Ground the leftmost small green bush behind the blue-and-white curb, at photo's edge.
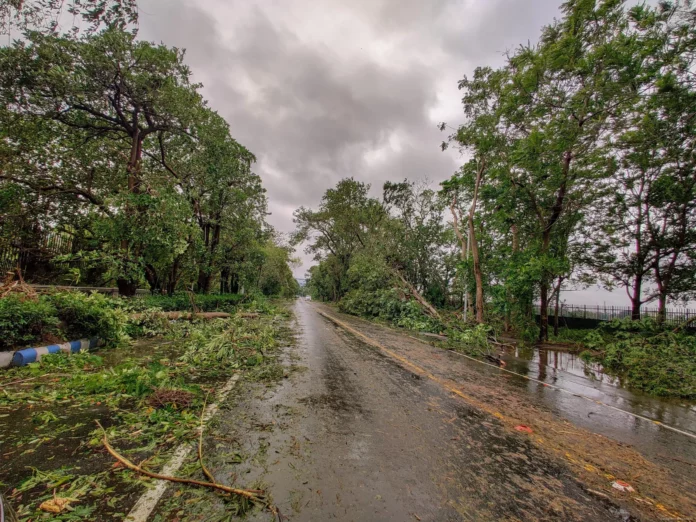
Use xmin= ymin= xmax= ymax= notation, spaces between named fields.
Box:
xmin=0 ymin=294 xmax=58 ymax=350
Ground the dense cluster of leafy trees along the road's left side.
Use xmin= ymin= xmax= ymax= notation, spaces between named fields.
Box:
xmin=0 ymin=23 xmax=297 ymax=295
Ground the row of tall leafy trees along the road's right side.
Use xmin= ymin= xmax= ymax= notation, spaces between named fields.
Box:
xmin=296 ymin=0 xmax=696 ymax=339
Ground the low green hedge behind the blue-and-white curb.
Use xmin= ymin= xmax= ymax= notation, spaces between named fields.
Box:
xmin=0 ymin=292 xmax=126 ymax=350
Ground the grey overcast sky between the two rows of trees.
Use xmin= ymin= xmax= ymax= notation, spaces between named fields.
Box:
xmin=135 ymin=0 xmax=557 ymax=274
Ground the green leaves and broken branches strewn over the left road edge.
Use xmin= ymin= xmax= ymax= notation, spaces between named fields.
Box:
xmin=0 ymin=299 xmax=292 ymax=522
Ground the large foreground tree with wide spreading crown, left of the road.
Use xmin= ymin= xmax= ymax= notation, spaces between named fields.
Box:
xmin=0 ymin=29 xmax=202 ymax=295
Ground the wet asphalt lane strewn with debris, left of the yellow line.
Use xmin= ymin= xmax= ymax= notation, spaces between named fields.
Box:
xmin=234 ymin=301 xmax=625 ymax=522
